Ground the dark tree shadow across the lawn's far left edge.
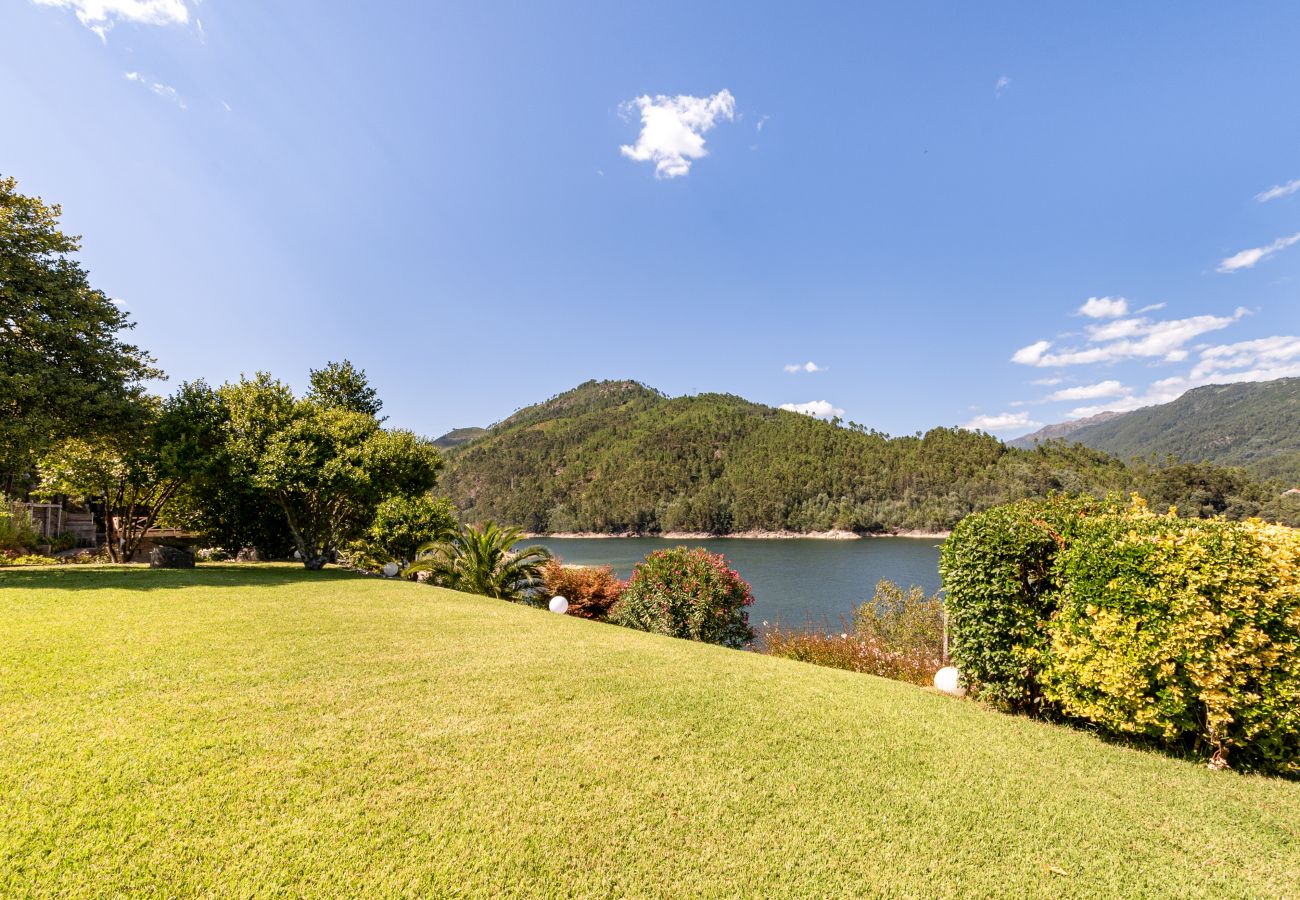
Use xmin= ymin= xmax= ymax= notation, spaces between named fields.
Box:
xmin=0 ymin=563 xmax=373 ymax=590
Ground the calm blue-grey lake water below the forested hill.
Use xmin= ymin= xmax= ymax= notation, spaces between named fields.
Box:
xmin=524 ymin=537 xmax=940 ymax=629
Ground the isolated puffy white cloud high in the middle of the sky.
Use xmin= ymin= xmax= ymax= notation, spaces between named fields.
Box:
xmin=619 ymin=90 xmax=736 ymax=178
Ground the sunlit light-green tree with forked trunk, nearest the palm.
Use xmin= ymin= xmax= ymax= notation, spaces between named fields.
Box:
xmin=220 ymin=373 xmax=442 ymax=568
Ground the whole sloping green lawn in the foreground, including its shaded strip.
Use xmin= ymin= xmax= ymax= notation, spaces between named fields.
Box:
xmin=0 ymin=566 xmax=1300 ymax=897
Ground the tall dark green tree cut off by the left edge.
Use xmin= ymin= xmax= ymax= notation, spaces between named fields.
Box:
xmin=0 ymin=177 xmax=161 ymax=480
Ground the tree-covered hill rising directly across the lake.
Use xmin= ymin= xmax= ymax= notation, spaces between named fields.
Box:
xmin=443 ymin=381 xmax=1300 ymax=533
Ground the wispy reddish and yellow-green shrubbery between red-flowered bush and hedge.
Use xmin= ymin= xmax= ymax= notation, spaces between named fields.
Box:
xmin=763 ymin=580 xmax=944 ymax=684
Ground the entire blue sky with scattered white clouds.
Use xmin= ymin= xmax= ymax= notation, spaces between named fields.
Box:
xmin=0 ymin=0 xmax=1300 ymax=437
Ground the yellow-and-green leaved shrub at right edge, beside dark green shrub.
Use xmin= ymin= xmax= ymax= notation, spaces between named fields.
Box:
xmin=1043 ymin=507 xmax=1300 ymax=775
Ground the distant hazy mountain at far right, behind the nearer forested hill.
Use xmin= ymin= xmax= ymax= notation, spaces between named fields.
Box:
xmin=1015 ymin=378 xmax=1300 ymax=484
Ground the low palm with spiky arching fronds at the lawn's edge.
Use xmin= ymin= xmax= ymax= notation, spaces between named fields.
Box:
xmin=406 ymin=522 xmax=551 ymax=600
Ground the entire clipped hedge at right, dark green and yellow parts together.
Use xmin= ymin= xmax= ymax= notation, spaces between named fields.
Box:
xmin=940 ymin=497 xmax=1300 ymax=776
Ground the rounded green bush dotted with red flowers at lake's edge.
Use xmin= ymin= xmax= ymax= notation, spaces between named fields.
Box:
xmin=610 ymin=546 xmax=754 ymax=648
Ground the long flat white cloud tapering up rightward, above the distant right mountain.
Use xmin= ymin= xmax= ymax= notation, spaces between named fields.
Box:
xmin=1011 ymin=308 xmax=1248 ymax=367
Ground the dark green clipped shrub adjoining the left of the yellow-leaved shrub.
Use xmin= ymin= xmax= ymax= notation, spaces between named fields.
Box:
xmin=939 ymin=496 xmax=1117 ymax=710
